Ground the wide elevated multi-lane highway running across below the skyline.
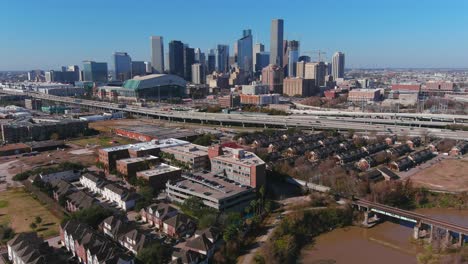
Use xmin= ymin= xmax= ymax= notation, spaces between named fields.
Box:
xmin=0 ymin=90 xmax=468 ymax=139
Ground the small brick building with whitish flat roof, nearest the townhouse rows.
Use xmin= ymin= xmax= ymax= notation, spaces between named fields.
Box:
xmin=136 ymin=163 xmax=182 ymax=190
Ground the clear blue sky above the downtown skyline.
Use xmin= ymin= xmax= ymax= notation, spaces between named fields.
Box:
xmin=0 ymin=0 xmax=468 ymax=70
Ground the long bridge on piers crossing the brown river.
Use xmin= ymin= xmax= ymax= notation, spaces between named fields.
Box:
xmin=352 ymin=199 xmax=468 ymax=247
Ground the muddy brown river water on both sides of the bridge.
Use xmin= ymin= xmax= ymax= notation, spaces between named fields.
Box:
xmin=300 ymin=209 xmax=468 ymax=264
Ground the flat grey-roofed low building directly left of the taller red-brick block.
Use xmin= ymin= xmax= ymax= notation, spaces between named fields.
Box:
xmin=161 ymin=144 xmax=210 ymax=171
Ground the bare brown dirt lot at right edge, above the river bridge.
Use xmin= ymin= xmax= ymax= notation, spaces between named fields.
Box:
xmin=411 ymin=157 xmax=468 ymax=192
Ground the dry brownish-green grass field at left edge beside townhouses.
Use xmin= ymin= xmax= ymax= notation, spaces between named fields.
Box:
xmin=0 ymin=188 xmax=60 ymax=238
